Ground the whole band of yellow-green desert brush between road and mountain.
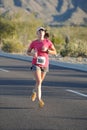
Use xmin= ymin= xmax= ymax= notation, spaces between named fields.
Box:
xmin=0 ymin=8 xmax=87 ymax=57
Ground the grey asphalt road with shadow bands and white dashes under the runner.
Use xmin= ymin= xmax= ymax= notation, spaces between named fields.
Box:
xmin=0 ymin=57 xmax=87 ymax=130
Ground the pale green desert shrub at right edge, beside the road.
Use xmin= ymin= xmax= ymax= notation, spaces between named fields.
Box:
xmin=60 ymin=40 xmax=87 ymax=57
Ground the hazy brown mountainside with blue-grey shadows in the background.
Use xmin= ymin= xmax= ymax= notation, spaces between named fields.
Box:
xmin=0 ymin=0 xmax=87 ymax=25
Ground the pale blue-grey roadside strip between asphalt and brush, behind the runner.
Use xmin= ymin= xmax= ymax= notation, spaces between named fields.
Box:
xmin=0 ymin=51 xmax=87 ymax=72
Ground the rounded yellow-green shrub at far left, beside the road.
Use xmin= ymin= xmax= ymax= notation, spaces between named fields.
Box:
xmin=2 ymin=39 xmax=24 ymax=53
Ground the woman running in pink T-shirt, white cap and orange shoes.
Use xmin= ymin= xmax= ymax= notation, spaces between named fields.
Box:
xmin=27 ymin=27 xmax=57 ymax=107
